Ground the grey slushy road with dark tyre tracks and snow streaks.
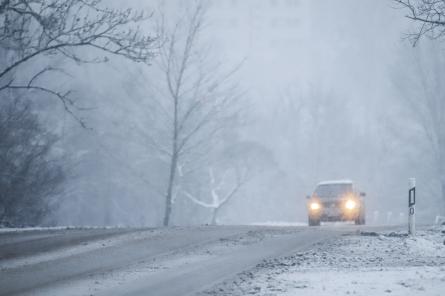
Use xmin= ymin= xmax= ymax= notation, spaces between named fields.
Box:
xmin=0 ymin=225 xmax=388 ymax=296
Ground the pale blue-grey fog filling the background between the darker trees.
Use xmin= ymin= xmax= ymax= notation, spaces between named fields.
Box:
xmin=1 ymin=0 xmax=445 ymax=226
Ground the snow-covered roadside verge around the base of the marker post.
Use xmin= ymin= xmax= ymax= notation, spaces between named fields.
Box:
xmin=202 ymin=226 xmax=445 ymax=296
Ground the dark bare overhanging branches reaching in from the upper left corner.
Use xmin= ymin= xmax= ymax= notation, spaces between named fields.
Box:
xmin=0 ymin=0 xmax=155 ymax=124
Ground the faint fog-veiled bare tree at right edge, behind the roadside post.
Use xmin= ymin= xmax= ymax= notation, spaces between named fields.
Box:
xmin=394 ymin=42 xmax=445 ymax=210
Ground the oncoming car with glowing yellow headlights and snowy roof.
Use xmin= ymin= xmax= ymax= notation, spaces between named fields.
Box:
xmin=307 ymin=180 xmax=366 ymax=226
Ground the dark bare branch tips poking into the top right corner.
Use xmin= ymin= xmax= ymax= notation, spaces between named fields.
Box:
xmin=394 ymin=0 xmax=445 ymax=46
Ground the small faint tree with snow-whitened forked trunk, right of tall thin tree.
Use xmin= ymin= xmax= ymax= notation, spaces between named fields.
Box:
xmin=178 ymin=135 xmax=276 ymax=225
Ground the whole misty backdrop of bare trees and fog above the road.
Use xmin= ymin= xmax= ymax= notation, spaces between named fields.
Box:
xmin=0 ymin=0 xmax=445 ymax=226
